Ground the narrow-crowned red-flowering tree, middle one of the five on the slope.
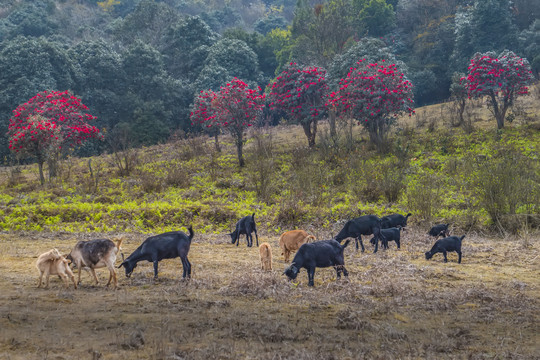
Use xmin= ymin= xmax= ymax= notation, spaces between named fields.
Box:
xmin=270 ymin=63 xmax=328 ymax=147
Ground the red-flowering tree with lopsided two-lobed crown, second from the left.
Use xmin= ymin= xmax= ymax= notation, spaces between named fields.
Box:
xmin=191 ymin=78 xmax=265 ymax=166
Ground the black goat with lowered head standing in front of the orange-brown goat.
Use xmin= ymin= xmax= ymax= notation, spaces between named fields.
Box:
xmin=283 ymin=239 xmax=350 ymax=286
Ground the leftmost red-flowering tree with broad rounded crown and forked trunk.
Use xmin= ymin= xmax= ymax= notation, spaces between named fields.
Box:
xmin=8 ymin=90 xmax=100 ymax=184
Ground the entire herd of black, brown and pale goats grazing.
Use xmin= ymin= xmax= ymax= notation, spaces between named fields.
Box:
xmin=36 ymin=213 xmax=465 ymax=289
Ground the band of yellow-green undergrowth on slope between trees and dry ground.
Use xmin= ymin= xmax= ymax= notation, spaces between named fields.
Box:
xmin=0 ymin=127 xmax=540 ymax=233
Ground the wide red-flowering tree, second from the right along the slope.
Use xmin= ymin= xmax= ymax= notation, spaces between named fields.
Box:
xmin=329 ymin=60 xmax=414 ymax=150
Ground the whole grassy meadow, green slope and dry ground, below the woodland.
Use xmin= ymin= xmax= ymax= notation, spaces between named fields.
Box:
xmin=0 ymin=95 xmax=540 ymax=359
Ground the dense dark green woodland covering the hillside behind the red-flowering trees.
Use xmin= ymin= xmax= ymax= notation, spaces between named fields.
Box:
xmin=0 ymin=0 xmax=540 ymax=161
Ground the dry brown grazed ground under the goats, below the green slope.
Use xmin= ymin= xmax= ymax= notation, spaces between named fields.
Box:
xmin=0 ymin=229 xmax=540 ymax=360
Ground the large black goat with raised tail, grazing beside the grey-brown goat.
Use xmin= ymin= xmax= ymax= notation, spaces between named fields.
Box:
xmin=118 ymin=226 xmax=194 ymax=280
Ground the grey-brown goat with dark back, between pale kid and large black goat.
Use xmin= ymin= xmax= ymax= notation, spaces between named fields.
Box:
xmin=67 ymin=239 xmax=122 ymax=289
